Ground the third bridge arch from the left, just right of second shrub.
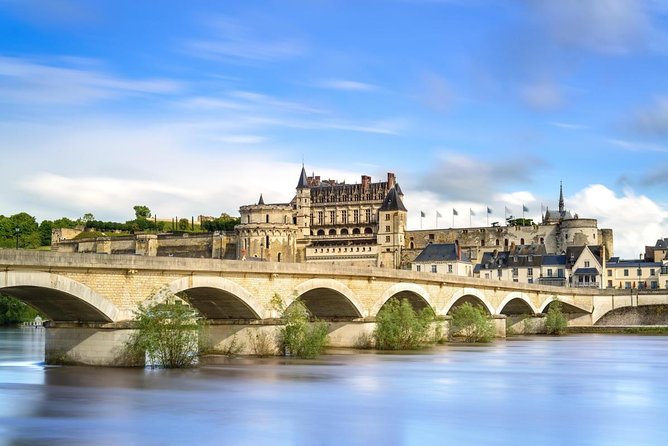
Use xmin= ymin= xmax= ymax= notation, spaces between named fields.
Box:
xmin=290 ymin=279 xmax=364 ymax=319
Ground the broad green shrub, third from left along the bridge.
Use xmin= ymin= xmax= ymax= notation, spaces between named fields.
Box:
xmin=374 ymin=299 xmax=435 ymax=350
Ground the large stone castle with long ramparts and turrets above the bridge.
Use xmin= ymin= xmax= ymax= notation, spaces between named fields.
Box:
xmin=54 ymin=166 xmax=613 ymax=268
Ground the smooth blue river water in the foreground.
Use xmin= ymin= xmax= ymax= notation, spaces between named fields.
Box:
xmin=0 ymin=328 xmax=668 ymax=446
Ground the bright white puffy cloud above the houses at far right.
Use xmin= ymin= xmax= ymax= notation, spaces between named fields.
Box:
xmin=568 ymin=184 xmax=668 ymax=258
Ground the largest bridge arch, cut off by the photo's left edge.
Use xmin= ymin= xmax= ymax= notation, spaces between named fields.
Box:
xmin=0 ymin=271 xmax=124 ymax=322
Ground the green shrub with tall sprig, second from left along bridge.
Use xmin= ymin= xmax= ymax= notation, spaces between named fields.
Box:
xmin=272 ymin=296 xmax=328 ymax=359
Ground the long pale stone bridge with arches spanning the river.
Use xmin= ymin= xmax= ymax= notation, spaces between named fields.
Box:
xmin=0 ymin=250 xmax=668 ymax=364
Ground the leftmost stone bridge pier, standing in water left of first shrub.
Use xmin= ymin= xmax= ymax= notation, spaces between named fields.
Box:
xmin=44 ymin=322 xmax=143 ymax=367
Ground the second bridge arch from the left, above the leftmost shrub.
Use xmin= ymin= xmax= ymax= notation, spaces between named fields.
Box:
xmin=160 ymin=276 xmax=268 ymax=319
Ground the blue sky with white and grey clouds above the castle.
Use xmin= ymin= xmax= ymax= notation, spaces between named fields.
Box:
xmin=0 ymin=0 xmax=668 ymax=258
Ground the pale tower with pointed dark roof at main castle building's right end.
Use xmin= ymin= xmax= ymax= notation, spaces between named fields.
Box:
xmin=376 ymin=182 xmax=407 ymax=268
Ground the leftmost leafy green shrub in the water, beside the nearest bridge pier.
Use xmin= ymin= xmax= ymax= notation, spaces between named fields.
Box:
xmin=126 ymin=303 xmax=202 ymax=368
